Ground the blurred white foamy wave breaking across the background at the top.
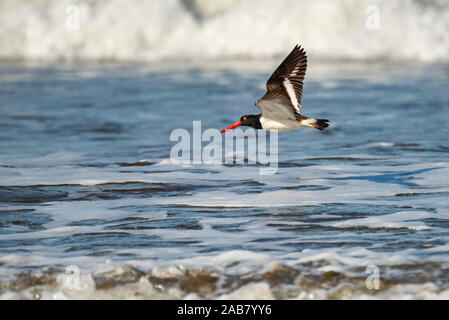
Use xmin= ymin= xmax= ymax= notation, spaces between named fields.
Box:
xmin=0 ymin=0 xmax=449 ymax=62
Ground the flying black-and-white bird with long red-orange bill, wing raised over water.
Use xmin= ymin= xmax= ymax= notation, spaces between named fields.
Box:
xmin=221 ymin=45 xmax=329 ymax=133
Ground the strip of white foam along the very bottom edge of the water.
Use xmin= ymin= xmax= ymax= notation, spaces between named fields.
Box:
xmin=0 ymin=277 xmax=449 ymax=300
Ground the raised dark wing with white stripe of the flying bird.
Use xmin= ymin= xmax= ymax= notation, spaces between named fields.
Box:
xmin=256 ymin=45 xmax=307 ymax=118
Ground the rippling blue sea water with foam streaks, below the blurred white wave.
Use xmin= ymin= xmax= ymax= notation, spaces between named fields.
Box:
xmin=0 ymin=60 xmax=449 ymax=299
